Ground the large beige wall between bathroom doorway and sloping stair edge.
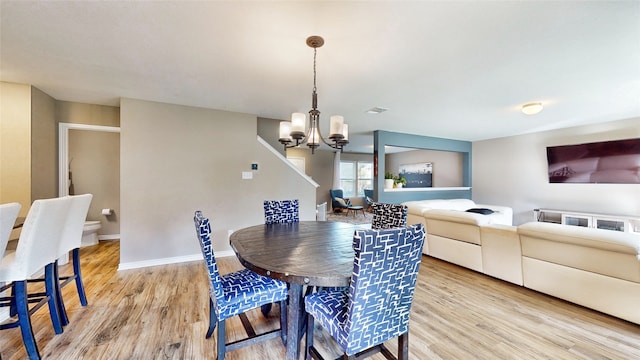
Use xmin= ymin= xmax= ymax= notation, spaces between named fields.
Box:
xmin=120 ymin=99 xmax=316 ymax=267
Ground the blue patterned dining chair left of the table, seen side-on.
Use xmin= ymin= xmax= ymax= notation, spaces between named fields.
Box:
xmin=193 ymin=211 xmax=287 ymax=360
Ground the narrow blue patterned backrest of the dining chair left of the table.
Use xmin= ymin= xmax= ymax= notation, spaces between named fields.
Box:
xmin=193 ymin=211 xmax=224 ymax=318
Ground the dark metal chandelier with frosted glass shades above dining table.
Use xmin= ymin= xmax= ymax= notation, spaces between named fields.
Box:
xmin=278 ymin=36 xmax=349 ymax=154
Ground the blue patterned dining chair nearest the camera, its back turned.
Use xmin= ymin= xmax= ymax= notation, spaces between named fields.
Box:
xmin=304 ymin=224 xmax=424 ymax=359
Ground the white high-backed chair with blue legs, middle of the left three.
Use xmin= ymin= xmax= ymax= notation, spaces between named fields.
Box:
xmin=0 ymin=197 xmax=71 ymax=359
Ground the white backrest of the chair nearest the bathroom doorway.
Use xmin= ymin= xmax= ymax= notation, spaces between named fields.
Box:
xmin=58 ymin=194 xmax=93 ymax=257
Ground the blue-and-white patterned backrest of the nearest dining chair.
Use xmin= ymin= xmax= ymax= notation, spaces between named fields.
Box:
xmin=345 ymin=224 xmax=425 ymax=355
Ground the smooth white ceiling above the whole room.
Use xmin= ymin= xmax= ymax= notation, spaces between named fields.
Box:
xmin=0 ymin=0 xmax=640 ymax=151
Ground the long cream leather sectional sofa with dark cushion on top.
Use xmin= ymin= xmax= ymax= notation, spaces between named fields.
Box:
xmin=404 ymin=199 xmax=640 ymax=324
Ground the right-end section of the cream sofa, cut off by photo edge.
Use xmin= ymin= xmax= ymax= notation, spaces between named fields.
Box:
xmin=516 ymin=222 xmax=640 ymax=324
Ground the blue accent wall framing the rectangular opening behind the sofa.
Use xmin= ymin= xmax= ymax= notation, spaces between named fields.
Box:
xmin=373 ymin=130 xmax=472 ymax=204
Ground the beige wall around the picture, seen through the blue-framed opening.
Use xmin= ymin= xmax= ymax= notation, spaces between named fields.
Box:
xmin=381 ymin=150 xmax=463 ymax=187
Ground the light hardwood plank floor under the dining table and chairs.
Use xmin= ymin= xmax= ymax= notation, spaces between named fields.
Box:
xmin=0 ymin=239 xmax=640 ymax=360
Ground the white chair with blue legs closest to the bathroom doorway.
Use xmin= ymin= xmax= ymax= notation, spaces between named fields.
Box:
xmin=55 ymin=194 xmax=93 ymax=325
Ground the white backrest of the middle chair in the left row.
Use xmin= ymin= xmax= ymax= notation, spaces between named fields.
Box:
xmin=3 ymin=197 xmax=71 ymax=282
